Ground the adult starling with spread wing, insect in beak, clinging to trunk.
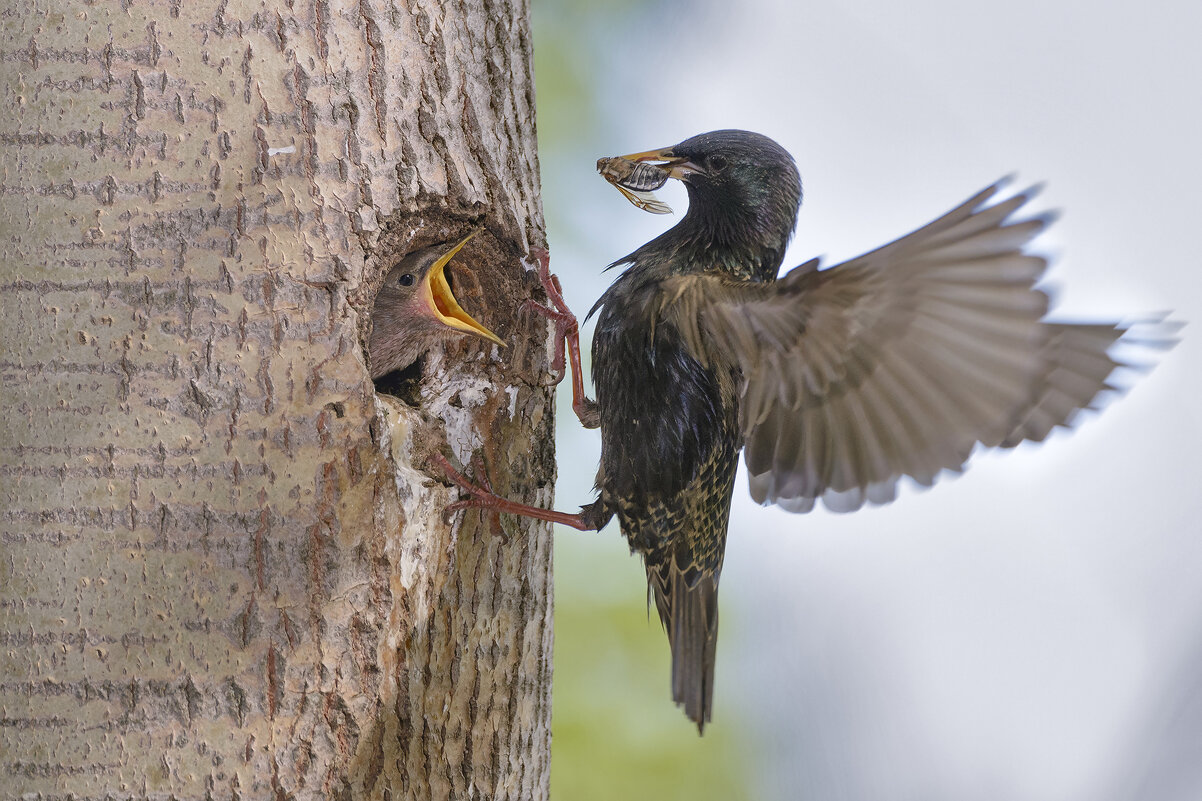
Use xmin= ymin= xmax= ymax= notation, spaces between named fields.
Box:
xmin=437 ymin=130 xmax=1168 ymax=730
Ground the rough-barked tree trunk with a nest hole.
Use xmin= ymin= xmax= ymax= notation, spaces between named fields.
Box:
xmin=0 ymin=0 xmax=553 ymax=799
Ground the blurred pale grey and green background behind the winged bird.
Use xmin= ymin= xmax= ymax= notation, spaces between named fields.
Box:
xmin=532 ymin=0 xmax=1202 ymax=801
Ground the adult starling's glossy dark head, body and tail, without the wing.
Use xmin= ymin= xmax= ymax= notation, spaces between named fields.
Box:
xmin=591 ymin=131 xmax=802 ymax=728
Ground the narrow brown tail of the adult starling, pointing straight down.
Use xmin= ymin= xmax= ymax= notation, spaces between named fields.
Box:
xmin=647 ymin=557 xmax=718 ymax=734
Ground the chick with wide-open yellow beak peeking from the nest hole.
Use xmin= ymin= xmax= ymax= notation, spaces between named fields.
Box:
xmin=368 ymin=232 xmax=505 ymax=379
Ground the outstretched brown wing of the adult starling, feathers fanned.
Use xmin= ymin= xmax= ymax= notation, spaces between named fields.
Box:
xmin=664 ymin=184 xmax=1124 ymax=511
